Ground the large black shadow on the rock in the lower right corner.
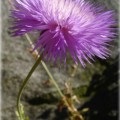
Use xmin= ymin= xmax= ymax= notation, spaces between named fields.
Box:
xmin=79 ymin=58 xmax=118 ymax=120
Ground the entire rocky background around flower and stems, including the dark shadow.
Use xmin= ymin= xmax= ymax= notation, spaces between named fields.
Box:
xmin=1 ymin=0 xmax=118 ymax=120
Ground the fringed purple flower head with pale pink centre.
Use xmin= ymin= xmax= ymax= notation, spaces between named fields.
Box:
xmin=12 ymin=0 xmax=115 ymax=66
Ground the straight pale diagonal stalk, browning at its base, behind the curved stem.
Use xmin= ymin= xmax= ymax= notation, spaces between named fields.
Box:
xmin=25 ymin=34 xmax=84 ymax=120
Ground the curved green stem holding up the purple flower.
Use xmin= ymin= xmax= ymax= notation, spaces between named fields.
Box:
xmin=17 ymin=55 xmax=42 ymax=116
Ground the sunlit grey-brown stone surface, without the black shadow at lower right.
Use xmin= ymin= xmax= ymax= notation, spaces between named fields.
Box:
xmin=2 ymin=0 xmax=118 ymax=120
